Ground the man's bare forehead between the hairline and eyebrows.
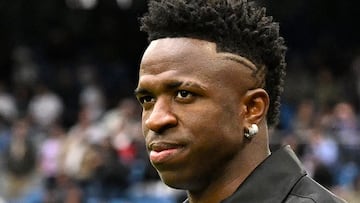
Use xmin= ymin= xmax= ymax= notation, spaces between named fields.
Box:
xmin=140 ymin=38 xmax=255 ymax=89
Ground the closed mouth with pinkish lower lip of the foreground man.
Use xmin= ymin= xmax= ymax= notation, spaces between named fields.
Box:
xmin=149 ymin=142 xmax=184 ymax=164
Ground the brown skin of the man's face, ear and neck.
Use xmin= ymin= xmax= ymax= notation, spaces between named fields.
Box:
xmin=135 ymin=38 xmax=270 ymax=203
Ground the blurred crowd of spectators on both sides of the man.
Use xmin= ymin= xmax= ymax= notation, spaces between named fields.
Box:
xmin=0 ymin=44 xmax=360 ymax=203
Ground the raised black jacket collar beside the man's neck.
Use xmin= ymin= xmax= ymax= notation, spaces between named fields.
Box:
xmin=222 ymin=146 xmax=306 ymax=203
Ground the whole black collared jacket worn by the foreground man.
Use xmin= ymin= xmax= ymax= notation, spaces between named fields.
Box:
xmin=185 ymin=146 xmax=345 ymax=203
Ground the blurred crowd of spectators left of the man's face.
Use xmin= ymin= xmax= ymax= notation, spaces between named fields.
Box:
xmin=0 ymin=44 xmax=184 ymax=203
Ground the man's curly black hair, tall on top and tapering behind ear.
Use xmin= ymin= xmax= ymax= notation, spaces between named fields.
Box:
xmin=140 ymin=0 xmax=286 ymax=125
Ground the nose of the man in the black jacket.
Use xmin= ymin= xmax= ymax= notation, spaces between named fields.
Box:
xmin=145 ymin=98 xmax=177 ymax=133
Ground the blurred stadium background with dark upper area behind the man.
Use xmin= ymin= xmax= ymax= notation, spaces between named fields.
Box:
xmin=0 ymin=0 xmax=360 ymax=203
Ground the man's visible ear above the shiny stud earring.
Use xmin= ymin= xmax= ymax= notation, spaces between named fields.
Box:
xmin=243 ymin=88 xmax=270 ymax=126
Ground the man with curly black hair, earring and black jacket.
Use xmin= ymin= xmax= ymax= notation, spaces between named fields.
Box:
xmin=135 ymin=0 xmax=342 ymax=203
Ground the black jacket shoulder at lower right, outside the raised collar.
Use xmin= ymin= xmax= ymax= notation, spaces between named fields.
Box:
xmin=285 ymin=176 xmax=345 ymax=203
